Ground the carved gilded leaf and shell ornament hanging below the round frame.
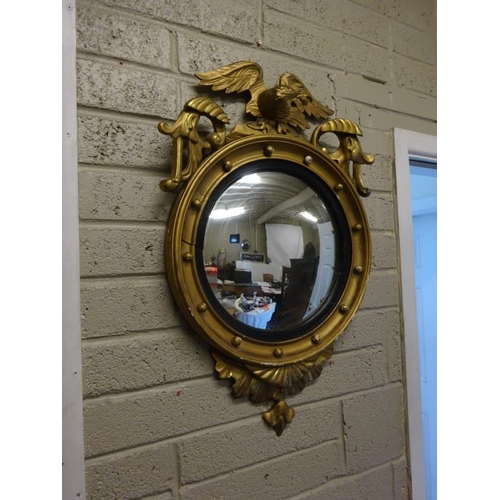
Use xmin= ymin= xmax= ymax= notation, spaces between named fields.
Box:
xmin=212 ymin=345 xmax=333 ymax=436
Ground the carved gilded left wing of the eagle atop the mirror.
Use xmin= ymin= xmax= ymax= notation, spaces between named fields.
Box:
xmin=195 ymin=61 xmax=265 ymax=117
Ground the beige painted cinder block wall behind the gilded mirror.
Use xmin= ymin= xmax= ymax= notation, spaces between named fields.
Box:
xmin=77 ymin=0 xmax=436 ymax=500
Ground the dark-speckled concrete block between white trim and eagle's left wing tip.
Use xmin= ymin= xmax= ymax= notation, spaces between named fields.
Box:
xmin=77 ymin=58 xmax=179 ymax=117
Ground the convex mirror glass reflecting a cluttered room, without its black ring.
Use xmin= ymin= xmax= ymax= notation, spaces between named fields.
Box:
xmin=203 ymin=171 xmax=338 ymax=331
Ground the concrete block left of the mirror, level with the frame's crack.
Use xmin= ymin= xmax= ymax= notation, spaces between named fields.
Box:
xmin=80 ymin=223 xmax=165 ymax=277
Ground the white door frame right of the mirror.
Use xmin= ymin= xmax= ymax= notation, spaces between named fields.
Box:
xmin=393 ymin=129 xmax=437 ymax=500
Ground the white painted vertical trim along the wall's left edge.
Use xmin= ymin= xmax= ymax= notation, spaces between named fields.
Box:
xmin=62 ymin=0 xmax=85 ymax=500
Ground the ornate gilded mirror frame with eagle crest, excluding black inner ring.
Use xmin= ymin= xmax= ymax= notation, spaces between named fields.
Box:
xmin=158 ymin=61 xmax=374 ymax=435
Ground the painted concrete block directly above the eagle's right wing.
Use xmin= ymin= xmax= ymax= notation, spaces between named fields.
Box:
xmin=263 ymin=10 xmax=345 ymax=70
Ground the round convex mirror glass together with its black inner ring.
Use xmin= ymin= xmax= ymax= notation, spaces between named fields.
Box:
xmin=198 ymin=160 xmax=351 ymax=341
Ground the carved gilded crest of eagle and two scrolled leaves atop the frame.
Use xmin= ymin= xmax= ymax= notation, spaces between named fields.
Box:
xmin=158 ymin=61 xmax=375 ymax=197
